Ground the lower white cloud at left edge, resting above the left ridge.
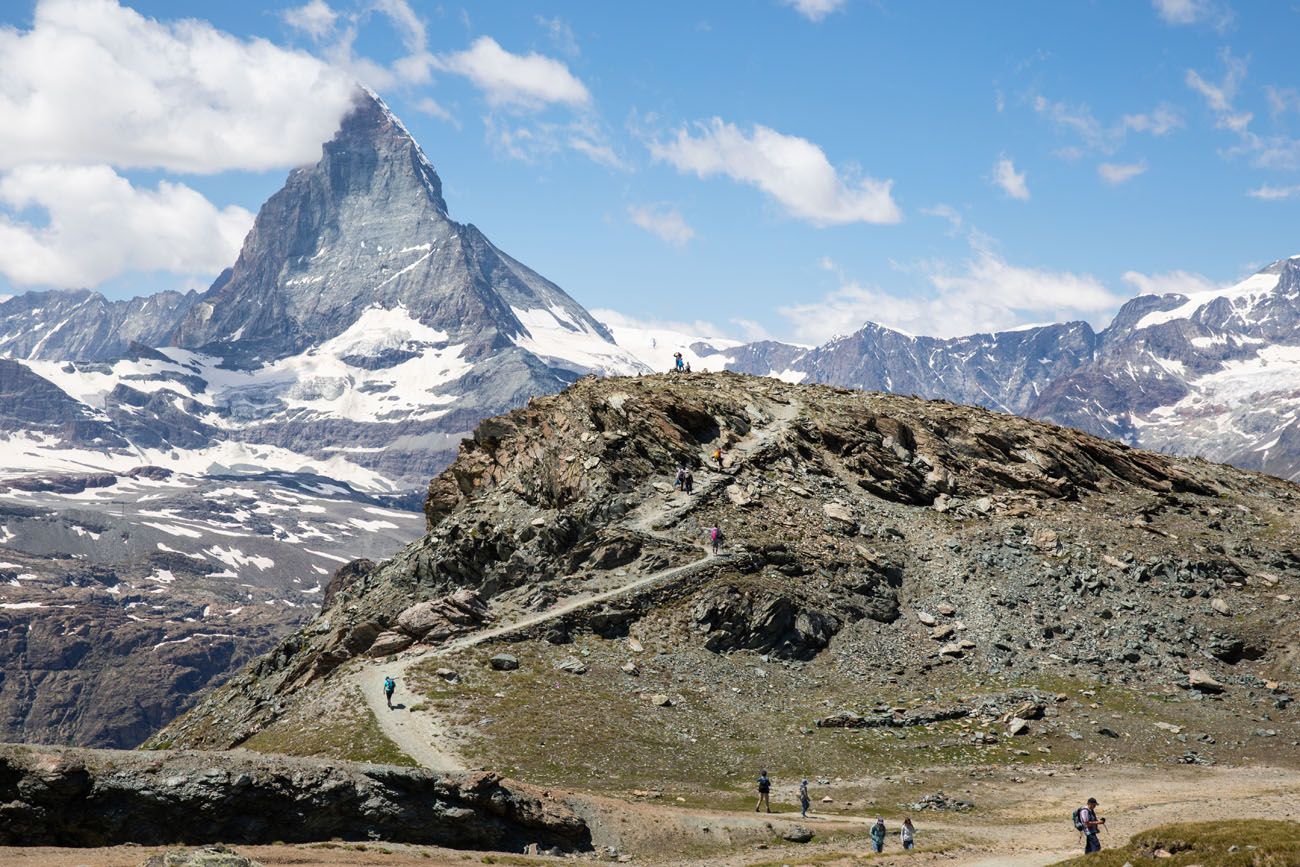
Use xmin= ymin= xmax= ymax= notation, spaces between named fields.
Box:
xmin=0 ymin=165 xmax=252 ymax=287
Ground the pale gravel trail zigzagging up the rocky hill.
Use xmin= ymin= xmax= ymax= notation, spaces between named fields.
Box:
xmin=347 ymin=392 xmax=801 ymax=771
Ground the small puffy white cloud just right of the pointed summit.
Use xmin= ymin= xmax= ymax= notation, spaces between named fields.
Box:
xmin=433 ymin=36 xmax=592 ymax=109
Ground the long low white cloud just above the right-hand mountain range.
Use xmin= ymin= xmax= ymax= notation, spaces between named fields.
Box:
xmin=780 ymin=233 xmax=1123 ymax=343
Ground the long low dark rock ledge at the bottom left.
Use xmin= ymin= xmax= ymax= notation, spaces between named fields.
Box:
xmin=0 ymin=746 xmax=592 ymax=851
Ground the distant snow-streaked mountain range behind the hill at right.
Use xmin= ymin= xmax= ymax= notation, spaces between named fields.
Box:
xmin=677 ymin=256 xmax=1300 ymax=478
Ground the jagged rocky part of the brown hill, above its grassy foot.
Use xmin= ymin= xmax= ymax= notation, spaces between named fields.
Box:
xmin=156 ymin=373 xmax=1300 ymax=747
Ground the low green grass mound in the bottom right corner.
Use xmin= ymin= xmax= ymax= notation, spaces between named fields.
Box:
xmin=1058 ymin=819 xmax=1300 ymax=867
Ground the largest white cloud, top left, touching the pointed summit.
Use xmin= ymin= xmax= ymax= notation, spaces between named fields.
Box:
xmin=0 ymin=0 xmax=354 ymax=173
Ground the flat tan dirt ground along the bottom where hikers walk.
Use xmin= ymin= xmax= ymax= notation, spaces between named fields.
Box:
xmin=0 ymin=766 xmax=1300 ymax=867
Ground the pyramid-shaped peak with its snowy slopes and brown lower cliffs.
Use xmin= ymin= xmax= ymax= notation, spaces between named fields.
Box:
xmin=0 ymin=92 xmax=644 ymax=746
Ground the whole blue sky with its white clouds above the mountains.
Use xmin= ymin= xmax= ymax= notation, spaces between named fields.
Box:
xmin=0 ymin=0 xmax=1300 ymax=342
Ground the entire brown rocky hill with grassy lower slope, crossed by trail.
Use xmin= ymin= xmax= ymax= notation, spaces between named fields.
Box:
xmin=152 ymin=373 xmax=1300 ymax=803
